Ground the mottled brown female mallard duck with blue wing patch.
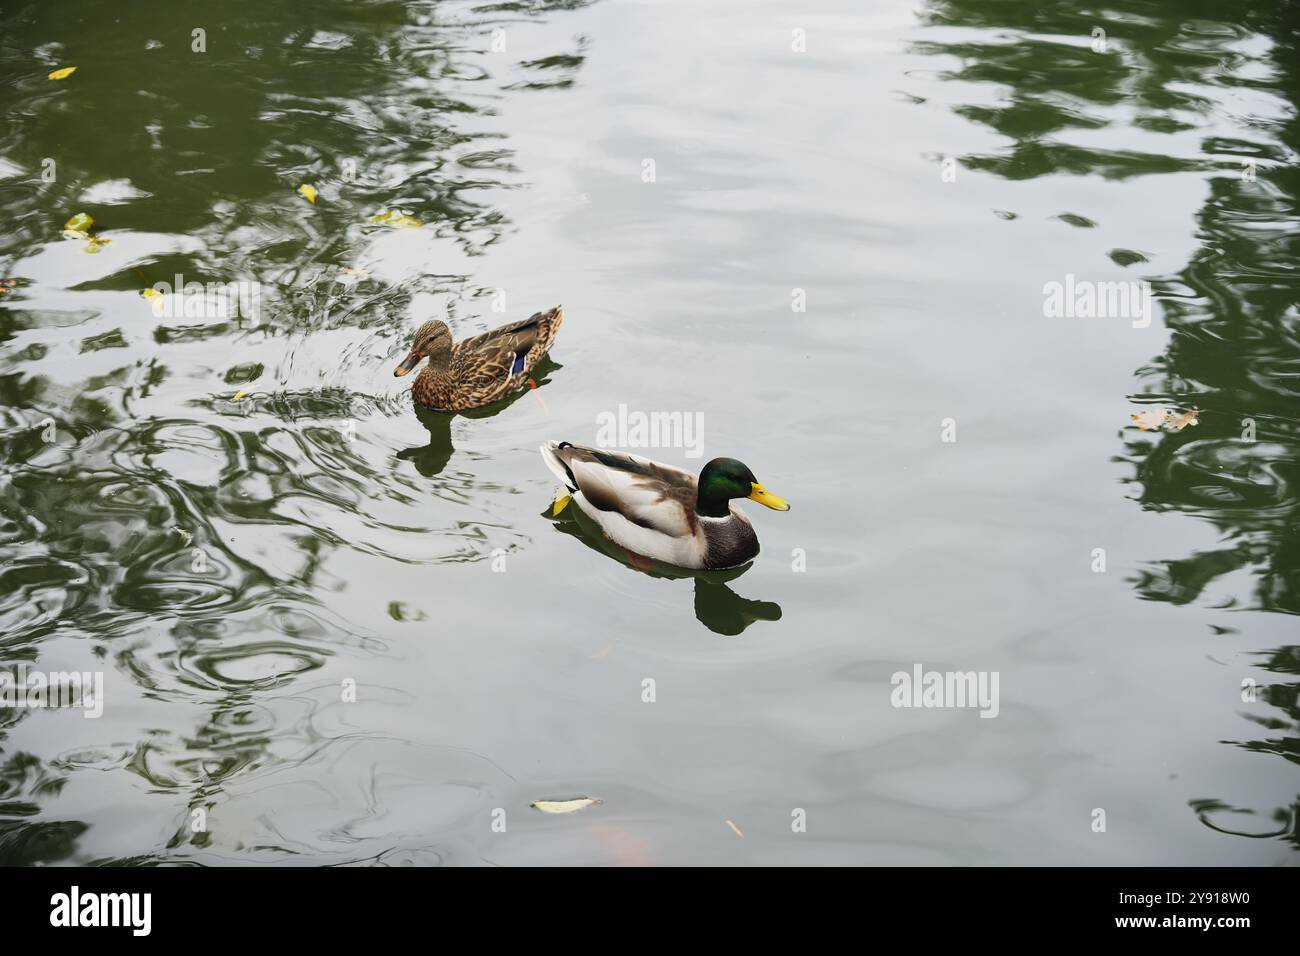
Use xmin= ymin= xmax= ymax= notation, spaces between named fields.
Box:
xmin=393 ymin=306 xmax=564 ymax=411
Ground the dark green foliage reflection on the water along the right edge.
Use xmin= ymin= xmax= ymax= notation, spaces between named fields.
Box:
xmin=920 ymin=0 xmax=1300 ymax=845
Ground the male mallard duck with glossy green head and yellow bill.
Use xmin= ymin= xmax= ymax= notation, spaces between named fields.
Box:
xmin=542 ymin=441 xmax=790 ymax=571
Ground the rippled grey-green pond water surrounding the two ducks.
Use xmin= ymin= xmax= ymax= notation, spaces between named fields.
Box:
xmin=0 ymin=0 xmax=1300 ymax=865
